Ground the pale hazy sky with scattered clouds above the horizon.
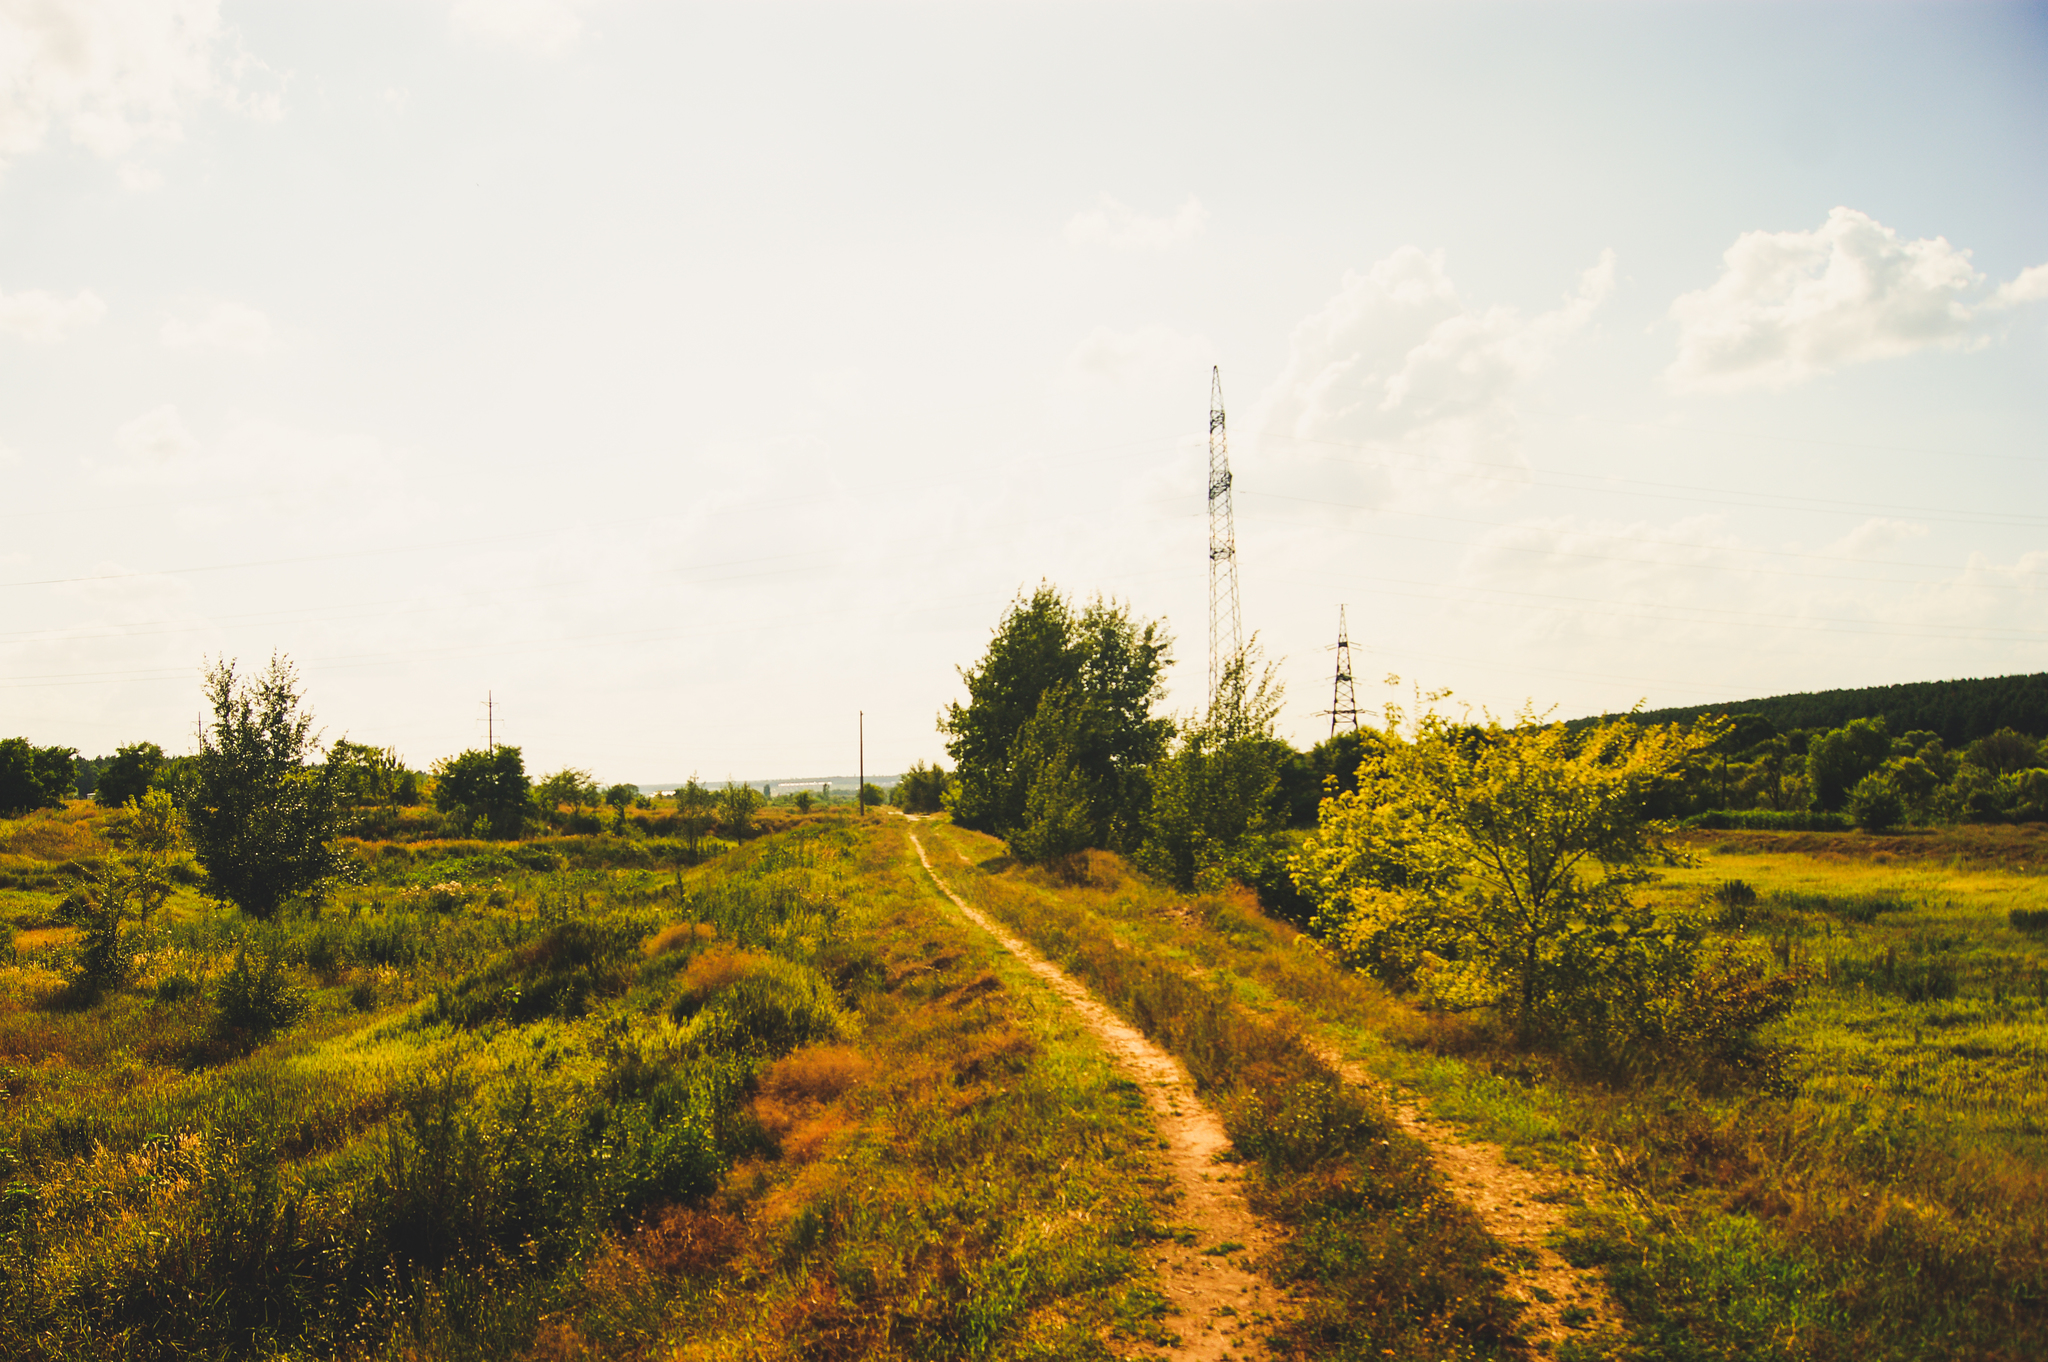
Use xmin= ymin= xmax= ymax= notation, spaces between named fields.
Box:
xmin=0 ymin=0 xmax=2048 ymax=784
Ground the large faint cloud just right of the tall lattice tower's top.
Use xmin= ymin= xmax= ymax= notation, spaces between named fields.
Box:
xmin=1257 ymin=246 xmax=1614 ymax=500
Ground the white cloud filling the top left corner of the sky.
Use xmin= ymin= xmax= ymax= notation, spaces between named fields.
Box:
xmin=0 ymin=0 xmax=283 ymax=173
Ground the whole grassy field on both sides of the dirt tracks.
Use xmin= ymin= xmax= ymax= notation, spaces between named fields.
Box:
xmin=0 ymin=805 xmax=2048 ymax=1360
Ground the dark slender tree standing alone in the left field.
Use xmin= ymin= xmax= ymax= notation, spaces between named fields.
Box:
xmin=184 ymin=655 xmax=350 ymax=920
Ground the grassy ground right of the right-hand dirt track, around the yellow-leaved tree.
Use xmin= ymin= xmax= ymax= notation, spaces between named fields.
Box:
xmin=921 ymin=829 xmax=2048 ymax=1360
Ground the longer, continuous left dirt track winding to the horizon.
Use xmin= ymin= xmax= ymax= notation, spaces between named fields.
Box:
xmin=909 ymin=832 xmax=1284 ymax=1362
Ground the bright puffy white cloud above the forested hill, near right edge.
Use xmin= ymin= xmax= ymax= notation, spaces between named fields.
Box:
xmin=1665 ymin=209 xmax=2048 ymax=391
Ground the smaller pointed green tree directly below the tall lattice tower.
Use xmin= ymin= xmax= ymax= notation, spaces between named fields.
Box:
xmin=1139 ymin=639 xmax=1286 ymax=889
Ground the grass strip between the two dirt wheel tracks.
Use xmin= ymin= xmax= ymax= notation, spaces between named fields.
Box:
xmin=928 ymin=827 xmax=1520 ymax=1358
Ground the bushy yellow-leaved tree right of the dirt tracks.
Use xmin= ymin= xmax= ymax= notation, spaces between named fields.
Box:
xmin=1294 ymin=711 xmax=1790 ymax=1040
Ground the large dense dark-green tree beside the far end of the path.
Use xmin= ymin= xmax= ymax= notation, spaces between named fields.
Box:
xmin=938 ymin=586 xmax=1174 ymax=858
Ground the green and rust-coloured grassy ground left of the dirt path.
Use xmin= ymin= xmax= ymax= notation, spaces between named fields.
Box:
xmin=0 ymin=805 xmax=1169 ymax=1358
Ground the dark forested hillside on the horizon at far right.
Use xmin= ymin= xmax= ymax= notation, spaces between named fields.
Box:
xmin=1605 ymin=672 xmax=2048 ymax=748
